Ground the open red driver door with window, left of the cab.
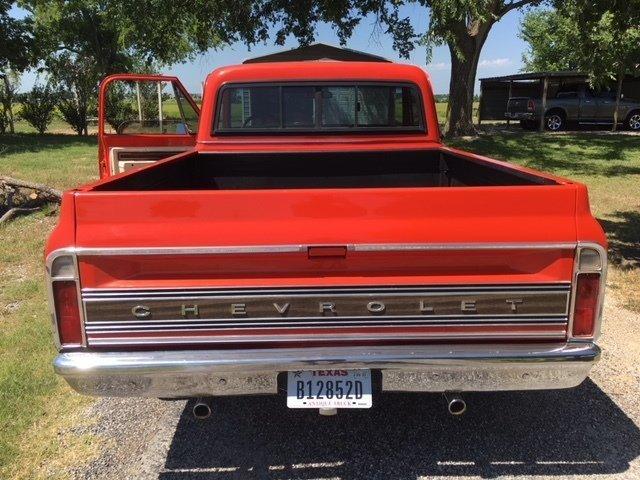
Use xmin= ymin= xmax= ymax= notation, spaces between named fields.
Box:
xmin=98 ymin=74 xmax=200 ymax=178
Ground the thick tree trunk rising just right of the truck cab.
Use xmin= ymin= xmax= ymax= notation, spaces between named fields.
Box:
xmin=445 ymin=22 xmax=492 ymax=137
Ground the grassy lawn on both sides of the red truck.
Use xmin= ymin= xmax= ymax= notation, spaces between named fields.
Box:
xmin=0 ymin=126 xmax=640 ymax=479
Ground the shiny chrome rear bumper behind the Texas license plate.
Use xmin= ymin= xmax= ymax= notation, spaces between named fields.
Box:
xmin=54 ymin=343 xmax=600 ymax=398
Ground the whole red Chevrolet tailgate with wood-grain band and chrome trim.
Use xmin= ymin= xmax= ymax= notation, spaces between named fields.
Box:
xmin=75 ymin=185 xmax=576 ymax=347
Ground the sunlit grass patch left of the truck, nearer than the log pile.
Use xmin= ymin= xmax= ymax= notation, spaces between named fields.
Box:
xmin=0 ymin=208 xmax=95 ymax=479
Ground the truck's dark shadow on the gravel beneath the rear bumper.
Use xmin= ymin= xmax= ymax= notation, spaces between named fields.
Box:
xmin=160 ymin=380 xmax=640 ymax=480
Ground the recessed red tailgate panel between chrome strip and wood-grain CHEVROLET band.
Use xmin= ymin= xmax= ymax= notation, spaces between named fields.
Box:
xmin=79 ymin=248 xmax=574 ymax=289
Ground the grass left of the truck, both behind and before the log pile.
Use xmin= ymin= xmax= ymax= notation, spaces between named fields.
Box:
xmin=0 ymin=134 xmax=97 ymax=479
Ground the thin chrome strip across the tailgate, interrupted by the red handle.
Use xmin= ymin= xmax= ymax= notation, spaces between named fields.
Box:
xmin=70 ymin=242 xmax=576 ymax=256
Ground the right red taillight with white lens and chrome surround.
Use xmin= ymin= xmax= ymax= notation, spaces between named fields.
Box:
xmin=571 ymin=247 xmax=607 ymax=338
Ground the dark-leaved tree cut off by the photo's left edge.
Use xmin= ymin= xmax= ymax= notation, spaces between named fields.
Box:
xmin=0 ymin=0 xmax=36 ymax=133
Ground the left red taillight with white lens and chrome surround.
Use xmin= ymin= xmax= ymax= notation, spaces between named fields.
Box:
xmin=48 ymin=255 xmax=82 ymax=348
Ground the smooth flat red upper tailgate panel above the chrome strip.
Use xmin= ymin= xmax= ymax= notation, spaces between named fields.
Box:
xmin=76 ymin=185 xmax=577 ymax=247
